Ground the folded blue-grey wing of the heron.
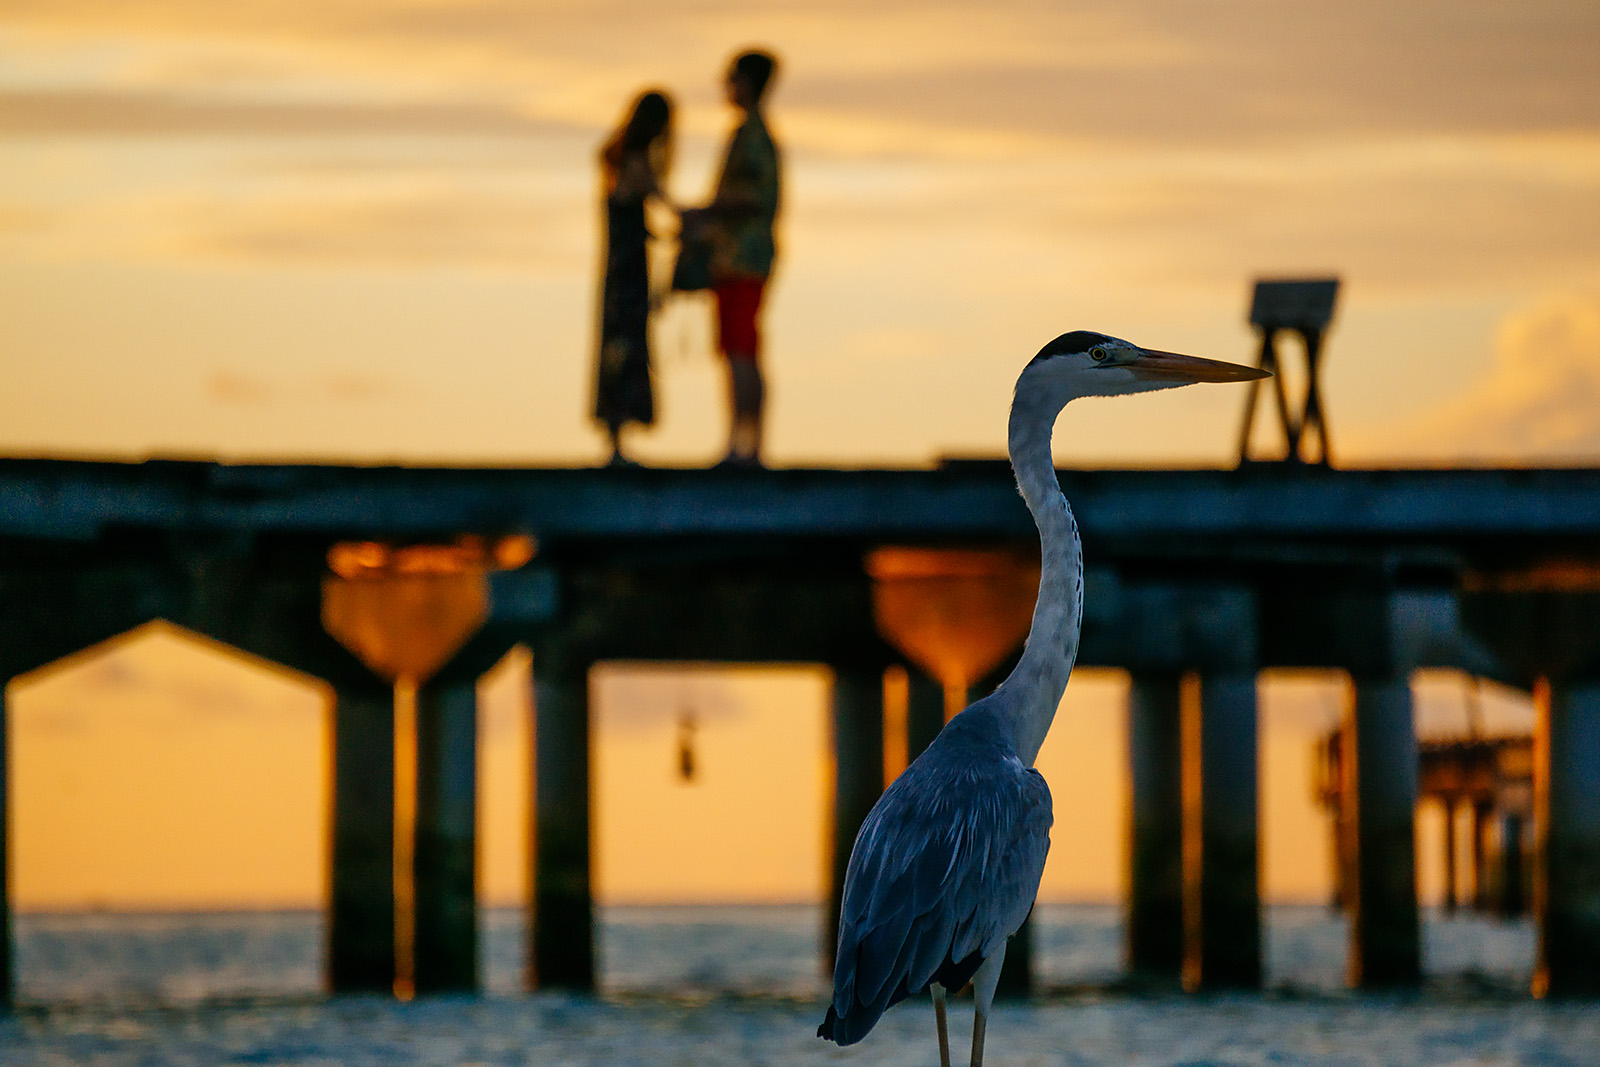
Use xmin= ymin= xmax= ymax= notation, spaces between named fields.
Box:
xmin=822 ymin=752 xmax=1051 ymax=1045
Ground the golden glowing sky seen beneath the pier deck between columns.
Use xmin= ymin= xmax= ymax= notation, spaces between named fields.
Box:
xmin=11 ymin=627 xmax=1437 ymax=912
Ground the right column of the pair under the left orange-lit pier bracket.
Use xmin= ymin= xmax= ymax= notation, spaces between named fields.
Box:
xmin=413 ymin=667 xmax=478 ymax=993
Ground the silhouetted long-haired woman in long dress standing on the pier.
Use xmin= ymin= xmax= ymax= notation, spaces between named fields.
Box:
xmin=595 ymin=91 xmax=672 ymax=464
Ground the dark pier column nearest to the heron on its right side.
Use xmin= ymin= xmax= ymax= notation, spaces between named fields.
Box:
xmin=1125 ymin=672 xmax=1184 ymax=984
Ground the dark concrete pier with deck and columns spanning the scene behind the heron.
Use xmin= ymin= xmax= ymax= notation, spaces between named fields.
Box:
xmin=0 ymin=459 xmax=1600 ymax=1001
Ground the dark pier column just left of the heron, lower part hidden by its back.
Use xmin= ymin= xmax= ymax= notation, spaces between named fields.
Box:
xmin=822 ymin=667 xmax=883 ymax=971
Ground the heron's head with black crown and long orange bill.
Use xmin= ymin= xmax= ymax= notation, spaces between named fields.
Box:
xmin=1018 ymin=330 xmax=1270 ymax=403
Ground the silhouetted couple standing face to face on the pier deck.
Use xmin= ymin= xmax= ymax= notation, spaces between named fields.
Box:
xmin=595 ymin=51 xmax=778 ymax=467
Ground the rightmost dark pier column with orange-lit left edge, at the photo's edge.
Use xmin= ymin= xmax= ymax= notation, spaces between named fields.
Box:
xmin=1533 ymin=678 xmax=1600 ymax=997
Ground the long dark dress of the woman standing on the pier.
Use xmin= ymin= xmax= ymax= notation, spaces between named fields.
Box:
xmin=595 ymin=179 xmax=656 ymax=427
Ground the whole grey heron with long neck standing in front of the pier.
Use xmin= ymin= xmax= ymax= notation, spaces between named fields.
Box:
xmin=818 ymin=330 xmax=1267 ymax=1067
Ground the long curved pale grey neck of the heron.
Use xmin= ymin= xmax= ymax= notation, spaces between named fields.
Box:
xmin=1000 ymin=390 xmax=1083 ymax=766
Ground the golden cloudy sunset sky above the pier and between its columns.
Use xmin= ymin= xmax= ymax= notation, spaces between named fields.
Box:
xmin=0 ymin=0 xmax=1600 ymax=905
